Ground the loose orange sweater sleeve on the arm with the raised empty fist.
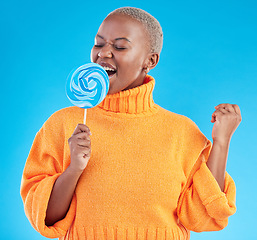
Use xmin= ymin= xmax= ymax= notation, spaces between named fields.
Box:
xmin=177 ymin=127 xmax=236 ymax=232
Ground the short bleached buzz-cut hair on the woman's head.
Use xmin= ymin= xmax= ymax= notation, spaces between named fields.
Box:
xmin=107 ymin=7 xmax=163 ymax=54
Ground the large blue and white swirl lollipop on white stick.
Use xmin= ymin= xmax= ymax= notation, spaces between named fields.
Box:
xmin=66 ymin=63 xmax=109 ymax=124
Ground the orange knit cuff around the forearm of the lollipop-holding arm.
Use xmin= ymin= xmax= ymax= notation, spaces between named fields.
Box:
xmin=25 ymin=174 xmax=76 ymax=238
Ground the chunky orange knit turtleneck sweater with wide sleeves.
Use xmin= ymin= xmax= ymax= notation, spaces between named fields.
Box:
xmin=21 ymin=76 xmax=235 ymax=240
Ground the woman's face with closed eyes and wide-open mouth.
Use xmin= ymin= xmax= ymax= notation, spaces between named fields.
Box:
xmin=91 ymin=15 xmax=157 ymax=94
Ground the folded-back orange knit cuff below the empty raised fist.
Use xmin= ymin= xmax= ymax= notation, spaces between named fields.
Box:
xmin=193 ymin=162 xmax=236 ymax=220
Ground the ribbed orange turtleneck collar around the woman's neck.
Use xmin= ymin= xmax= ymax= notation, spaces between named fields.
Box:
xmin=98 ymin=75 xmax=156 ymax=114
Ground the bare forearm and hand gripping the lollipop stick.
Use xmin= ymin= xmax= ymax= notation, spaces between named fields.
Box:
xmin=45 ymin=124 xmax=91 ymax=226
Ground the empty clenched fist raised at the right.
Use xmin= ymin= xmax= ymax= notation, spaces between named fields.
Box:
xmin=211 ymin=103 xmax=242 ymax=144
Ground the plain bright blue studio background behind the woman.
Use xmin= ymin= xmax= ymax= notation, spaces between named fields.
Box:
xmin=0 ymin=0 xmax=257 ymax=240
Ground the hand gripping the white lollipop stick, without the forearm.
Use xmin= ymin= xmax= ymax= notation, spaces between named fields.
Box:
xmin=68 ymin=124 xmax=91 ymax=171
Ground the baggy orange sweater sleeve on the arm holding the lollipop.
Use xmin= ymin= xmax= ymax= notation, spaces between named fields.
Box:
xmin=21 ymin=112 xmax=76 ymax=238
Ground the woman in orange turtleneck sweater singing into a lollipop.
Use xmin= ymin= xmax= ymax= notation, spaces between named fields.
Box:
xmin=21 ymin=8 xmax=241 ymax=240
